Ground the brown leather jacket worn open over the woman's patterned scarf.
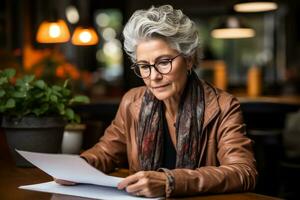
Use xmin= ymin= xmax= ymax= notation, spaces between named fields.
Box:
xmin=82 ymin=82 xmax=257 ymax=196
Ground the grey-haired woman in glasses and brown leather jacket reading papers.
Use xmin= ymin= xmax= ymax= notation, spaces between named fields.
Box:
xmin=56 ymin=5 xmax=257 ymax=197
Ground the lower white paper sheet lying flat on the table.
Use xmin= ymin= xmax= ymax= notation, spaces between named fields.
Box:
xmin=19 ymin=181 xmax=161 ymax=200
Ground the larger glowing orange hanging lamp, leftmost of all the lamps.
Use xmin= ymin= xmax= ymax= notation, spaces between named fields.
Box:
xmin=36 ymin=20 xmax=70 ymax=43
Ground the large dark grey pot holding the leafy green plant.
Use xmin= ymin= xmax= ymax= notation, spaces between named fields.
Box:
xmin=2 ymin=116 xmax=66 ymax=167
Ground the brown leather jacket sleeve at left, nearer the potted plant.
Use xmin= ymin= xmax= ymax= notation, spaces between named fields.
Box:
xmin=81 ymin=94 xmax=130 ymax=173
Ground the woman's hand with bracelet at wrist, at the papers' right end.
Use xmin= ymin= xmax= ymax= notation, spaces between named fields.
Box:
xmin=118 ymin=171 xmax=167 ymax=197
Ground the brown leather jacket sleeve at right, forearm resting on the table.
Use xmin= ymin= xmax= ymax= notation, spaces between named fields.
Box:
xmin=166 ymin=98 xmax=257 ymax=196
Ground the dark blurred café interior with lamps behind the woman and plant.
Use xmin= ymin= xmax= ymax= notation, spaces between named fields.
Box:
xmin=0 ymin=0 xmax=300 ymax=199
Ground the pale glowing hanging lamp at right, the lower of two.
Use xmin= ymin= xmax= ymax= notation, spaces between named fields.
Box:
xmin=211 ymin=17 xmax=255 ymax=39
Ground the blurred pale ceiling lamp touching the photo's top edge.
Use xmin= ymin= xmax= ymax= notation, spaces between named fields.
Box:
xmin=233 ymin=1 xmax=278 ymax=12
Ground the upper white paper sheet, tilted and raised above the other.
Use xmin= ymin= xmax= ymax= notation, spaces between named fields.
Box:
xmin=16 ymin=150 xmax=123 ymax=187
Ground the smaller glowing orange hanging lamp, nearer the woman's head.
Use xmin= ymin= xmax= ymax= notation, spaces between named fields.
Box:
xmin=72 ymin=27 xmax=99 ymax=46
